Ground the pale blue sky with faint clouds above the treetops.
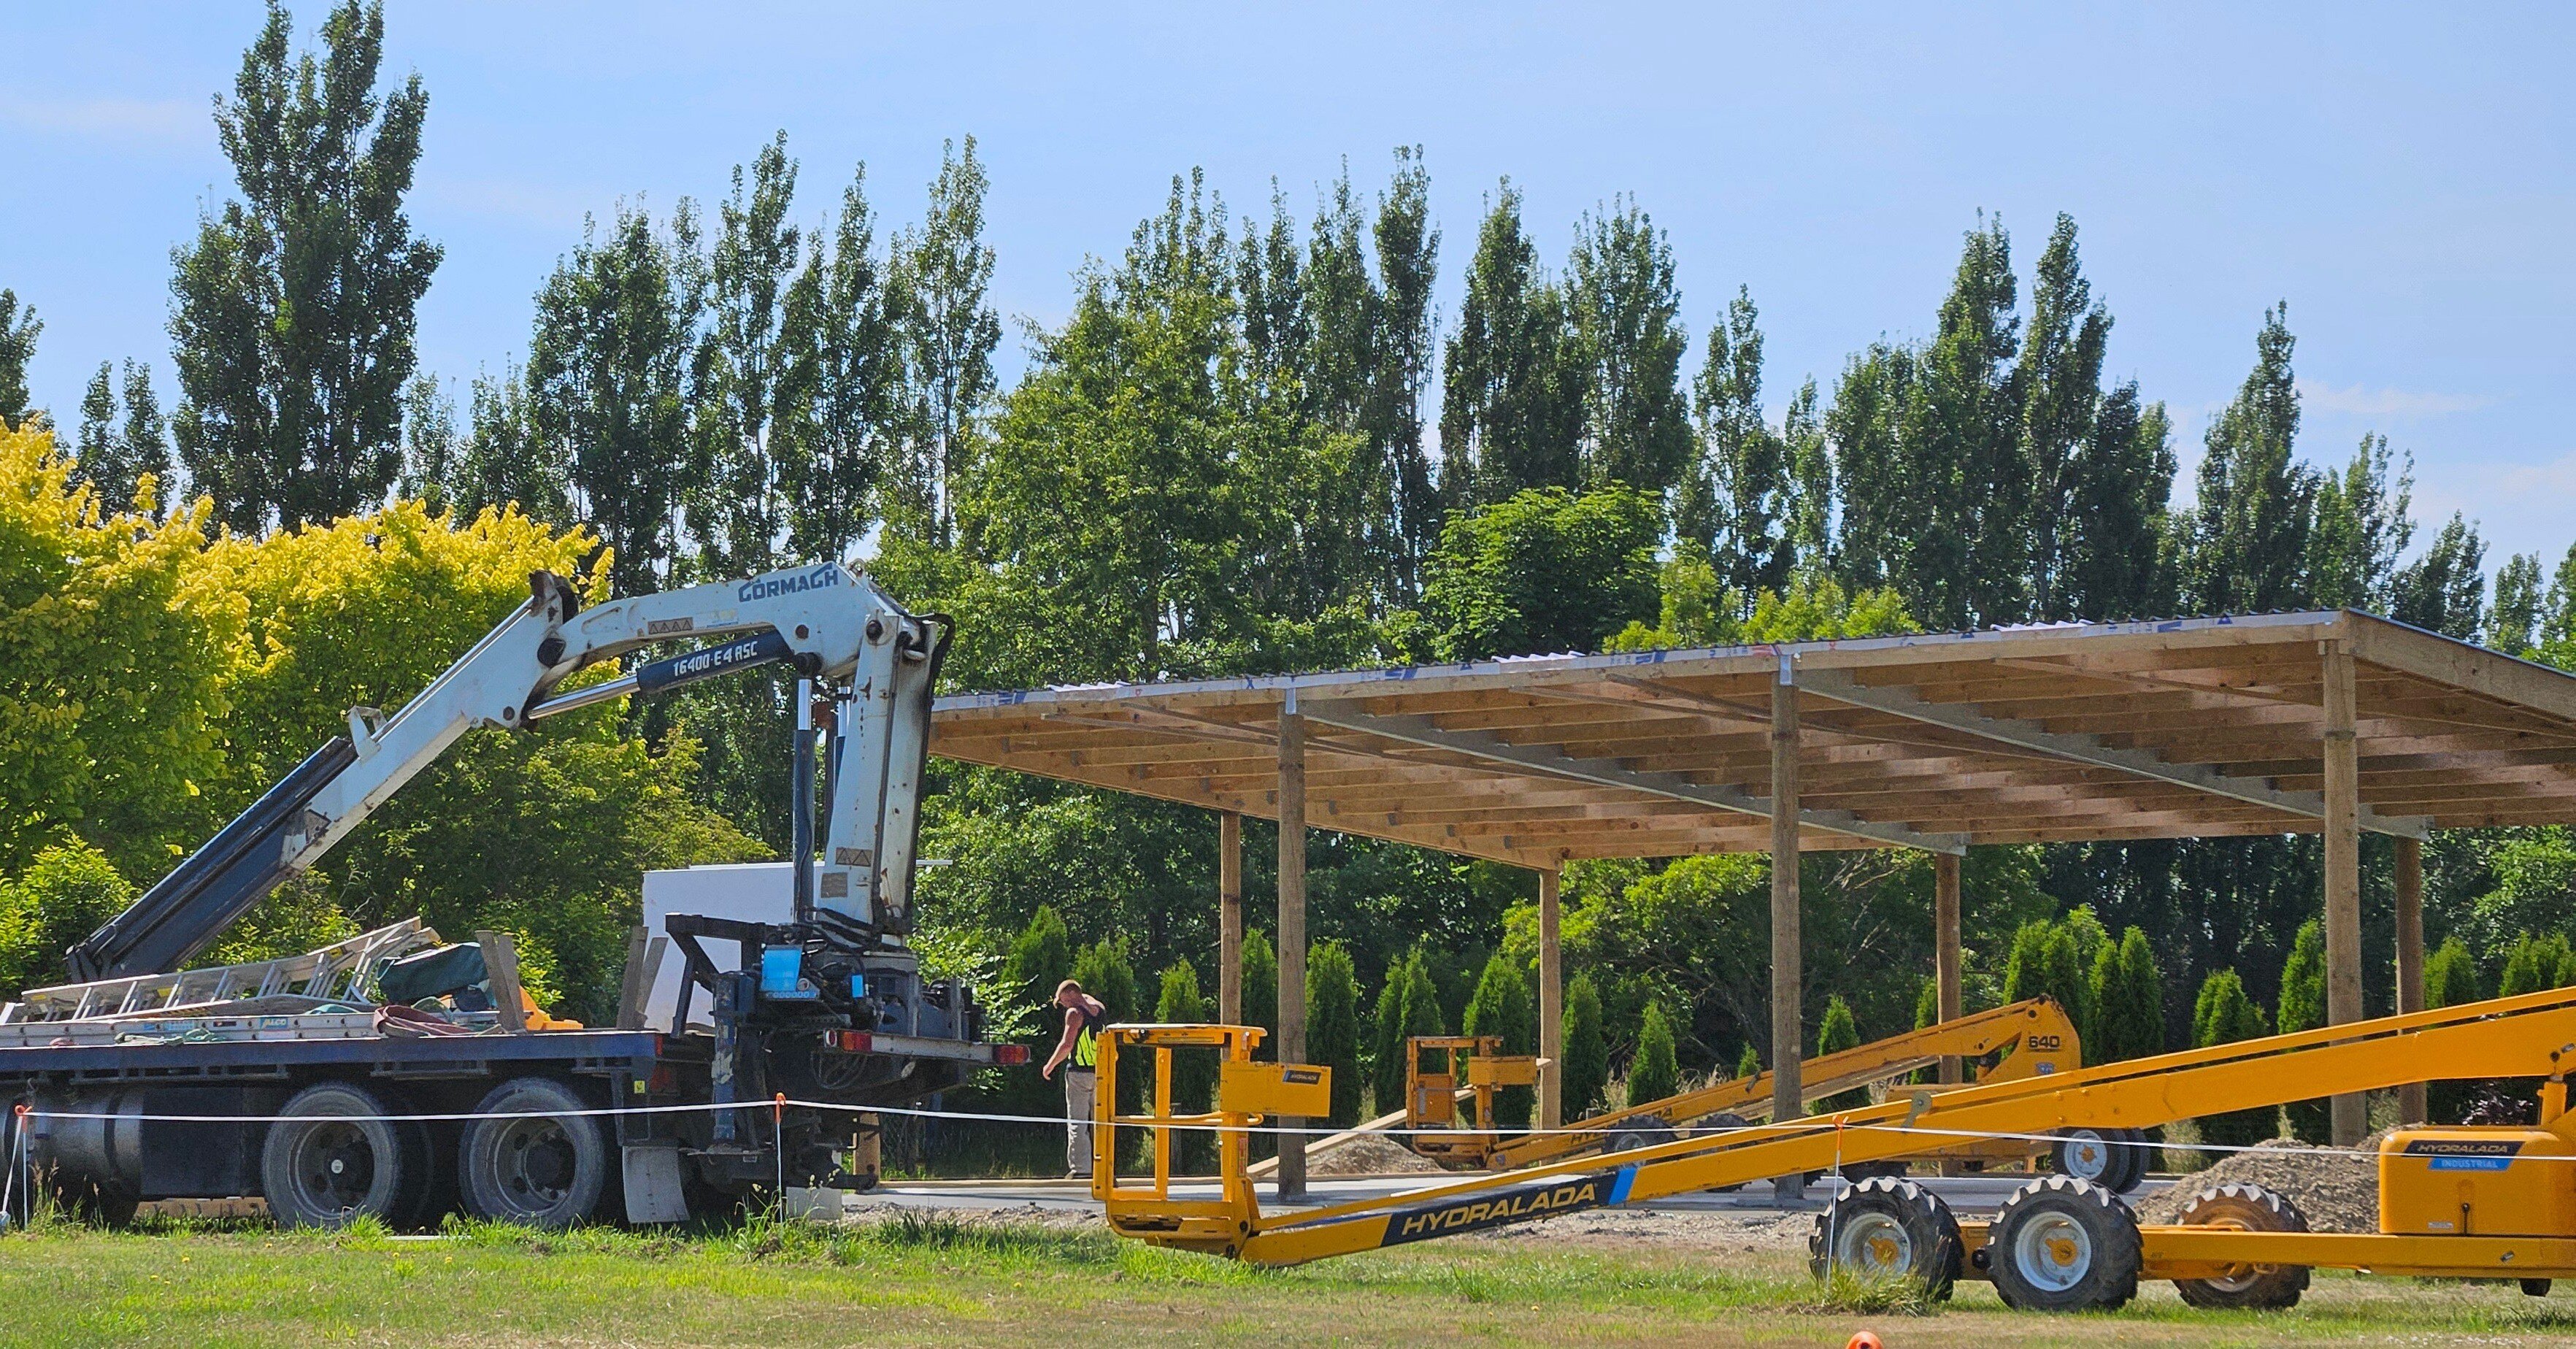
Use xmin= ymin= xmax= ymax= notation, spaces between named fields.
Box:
xmin=0 ymin=0 xmax=2576 ymax=561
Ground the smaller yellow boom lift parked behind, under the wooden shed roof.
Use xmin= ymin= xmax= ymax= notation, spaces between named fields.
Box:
xmin=1401 ymin=999 xmax=2148 ymax=1194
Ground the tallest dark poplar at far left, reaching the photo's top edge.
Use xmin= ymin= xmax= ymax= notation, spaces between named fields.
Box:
xmin=170 ymin=0 xmax=440 ymax=533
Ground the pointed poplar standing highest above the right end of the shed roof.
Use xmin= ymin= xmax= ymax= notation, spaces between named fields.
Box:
xmin=2185 ymin=304 xmax=2318 ymax=612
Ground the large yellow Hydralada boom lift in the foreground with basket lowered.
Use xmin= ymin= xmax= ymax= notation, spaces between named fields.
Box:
xmin=1092 ymin=988 xmax=2576 ymax=1310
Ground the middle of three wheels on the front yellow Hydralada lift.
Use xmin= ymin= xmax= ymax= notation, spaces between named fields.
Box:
xmin=1986 ymin=1177 xmax=2141 ymax=1310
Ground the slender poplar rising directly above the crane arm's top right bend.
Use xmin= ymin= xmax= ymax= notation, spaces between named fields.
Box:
xmin=894 ymin=137 xmax=1002 ymax=548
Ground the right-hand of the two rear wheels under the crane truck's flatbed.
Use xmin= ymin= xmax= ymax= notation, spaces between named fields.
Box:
xmin=456 ymin=1076 xmax=608 ymax=1228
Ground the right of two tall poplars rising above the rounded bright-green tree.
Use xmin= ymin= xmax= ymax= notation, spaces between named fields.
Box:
xmin=1566 ymin=199 xmax=1690 ymax=497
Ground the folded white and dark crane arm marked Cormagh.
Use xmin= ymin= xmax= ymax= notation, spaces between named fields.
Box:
xmin=69 ymin=564 xmax=945 ymax=981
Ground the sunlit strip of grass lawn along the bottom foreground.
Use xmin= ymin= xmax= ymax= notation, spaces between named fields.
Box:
xmin=0 ymin=1221 xmax=2576 ymax=1349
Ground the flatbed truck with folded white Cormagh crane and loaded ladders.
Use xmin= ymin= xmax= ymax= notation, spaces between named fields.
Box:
xmin=0 ymin=564 xmax=1026 ymax=1226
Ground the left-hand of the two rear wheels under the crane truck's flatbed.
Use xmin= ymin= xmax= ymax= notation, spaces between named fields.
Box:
xmin=260 ymin=1081 xmax=430 ymax=1228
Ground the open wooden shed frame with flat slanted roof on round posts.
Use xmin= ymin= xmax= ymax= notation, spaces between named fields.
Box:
xmin=932 ymin=610 xmax=2576 ymax=1184
